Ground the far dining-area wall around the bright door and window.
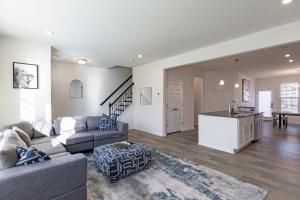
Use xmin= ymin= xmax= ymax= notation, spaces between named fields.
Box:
xmin=256 ymin=75 xmax=300 ymax=124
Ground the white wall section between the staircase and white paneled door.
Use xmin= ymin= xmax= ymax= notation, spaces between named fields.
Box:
xmin=133 ymin=66 xmax=165 ymax=136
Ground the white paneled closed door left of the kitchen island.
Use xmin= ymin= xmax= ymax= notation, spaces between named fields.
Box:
xmin=166 ymin=81 xmax=183 ymax=133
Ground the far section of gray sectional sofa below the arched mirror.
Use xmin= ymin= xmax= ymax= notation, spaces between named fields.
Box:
xmin=54 ymin=116 xmax=128 ymax=153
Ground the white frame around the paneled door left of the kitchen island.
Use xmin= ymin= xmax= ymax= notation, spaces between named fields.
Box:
xmin=164 ymin=79 xmax=184 ymax=135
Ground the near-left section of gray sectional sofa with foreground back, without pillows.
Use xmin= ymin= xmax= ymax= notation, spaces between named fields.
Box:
xmin=0 ymin=122 xmax=87 ymax=200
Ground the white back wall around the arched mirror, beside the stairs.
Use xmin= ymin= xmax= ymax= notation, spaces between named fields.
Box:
xmin=52 ymin=61 xmax=132 ymax=118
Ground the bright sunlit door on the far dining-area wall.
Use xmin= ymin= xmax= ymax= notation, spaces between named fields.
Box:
xmin=258 ymin=90 xmax=273 ymax=118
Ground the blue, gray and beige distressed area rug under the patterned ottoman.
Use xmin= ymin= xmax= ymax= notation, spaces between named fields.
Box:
xmin=86 ymin=149 xmax=268 ymax=200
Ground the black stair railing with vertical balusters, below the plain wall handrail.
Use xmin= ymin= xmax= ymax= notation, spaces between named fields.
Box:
xmin=109 ymin=83 xmax=134 ymax=119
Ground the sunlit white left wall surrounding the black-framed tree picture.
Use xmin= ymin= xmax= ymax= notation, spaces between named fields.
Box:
xmin=0 ymin=36 xmax=51 ymax=126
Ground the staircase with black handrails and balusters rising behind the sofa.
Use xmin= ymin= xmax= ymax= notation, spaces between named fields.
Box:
xmin=100 ymin=76 xmax=134 ymax=119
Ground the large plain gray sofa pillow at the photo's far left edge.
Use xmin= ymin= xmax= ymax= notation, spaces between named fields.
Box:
xmin=0 ymin=129 xmax=26 ymax=170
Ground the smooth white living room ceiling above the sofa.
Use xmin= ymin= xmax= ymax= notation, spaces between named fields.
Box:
xmin=0 ymin=0 xmax=300 ymax=68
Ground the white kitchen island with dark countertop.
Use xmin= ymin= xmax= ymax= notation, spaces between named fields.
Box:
xmin=198 ymin=111 xmax=259 ymax=154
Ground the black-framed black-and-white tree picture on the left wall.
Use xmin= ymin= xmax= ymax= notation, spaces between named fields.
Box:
xmin=13 ymin=62 xmax=39 ymax=89
